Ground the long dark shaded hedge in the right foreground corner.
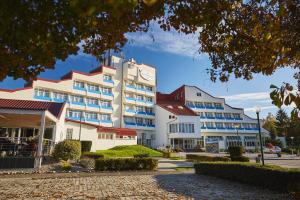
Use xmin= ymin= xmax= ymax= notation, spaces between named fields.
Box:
xmin=194 ymin=162 xmax=300 ymax=196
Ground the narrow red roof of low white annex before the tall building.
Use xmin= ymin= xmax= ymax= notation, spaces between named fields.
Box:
xmin=66 ymin=119 xmax=137 ymax=136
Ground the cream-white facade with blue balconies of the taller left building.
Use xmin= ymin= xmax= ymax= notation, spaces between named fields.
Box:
xmin=0 ymin=56 xmax=156 ymax=150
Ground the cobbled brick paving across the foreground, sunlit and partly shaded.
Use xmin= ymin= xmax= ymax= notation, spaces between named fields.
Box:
xmin=0 ymin=172 xmax=288 ymax=200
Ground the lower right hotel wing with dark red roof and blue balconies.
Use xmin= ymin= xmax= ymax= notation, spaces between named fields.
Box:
xmin=156 ymin=85 xmax=269 ymax=152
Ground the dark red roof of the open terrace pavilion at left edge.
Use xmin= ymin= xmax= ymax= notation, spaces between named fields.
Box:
xmin=0 ymin=99 xmax=64 ymax=118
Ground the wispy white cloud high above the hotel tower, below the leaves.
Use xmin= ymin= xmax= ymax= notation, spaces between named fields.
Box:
xmin=126 ymin=23 xmax=206 ymax=59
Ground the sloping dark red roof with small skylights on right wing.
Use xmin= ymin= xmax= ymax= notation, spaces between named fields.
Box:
xmin=156 ymin=101 xmax=198 ymax=116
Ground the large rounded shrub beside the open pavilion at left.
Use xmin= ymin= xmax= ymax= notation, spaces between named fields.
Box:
xmin=52 ymin=140 xmax=81 ymax=161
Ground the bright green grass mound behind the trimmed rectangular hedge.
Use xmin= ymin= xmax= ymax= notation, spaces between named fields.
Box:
xmin=96 ymin=145 xmax=162 ymax=158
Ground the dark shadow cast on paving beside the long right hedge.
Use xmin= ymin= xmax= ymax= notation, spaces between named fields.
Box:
xmin=155 ymin=173 xmax=288 ymax=200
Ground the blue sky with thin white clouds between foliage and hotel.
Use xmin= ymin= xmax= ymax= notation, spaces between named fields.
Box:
xmin=0 ymin=26 xmax=296 ymax=117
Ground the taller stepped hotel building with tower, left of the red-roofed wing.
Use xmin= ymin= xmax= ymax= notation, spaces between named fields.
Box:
xmin=0 ymin=56 xmax=156 ymax=151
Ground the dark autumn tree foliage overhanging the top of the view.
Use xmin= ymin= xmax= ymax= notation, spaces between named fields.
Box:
xmin=0 ymin=0 xmax=300 ymax=115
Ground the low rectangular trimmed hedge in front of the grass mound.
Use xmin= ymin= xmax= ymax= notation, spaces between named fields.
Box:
xmin=95 ymin=158 xmax=158 ymax=171
